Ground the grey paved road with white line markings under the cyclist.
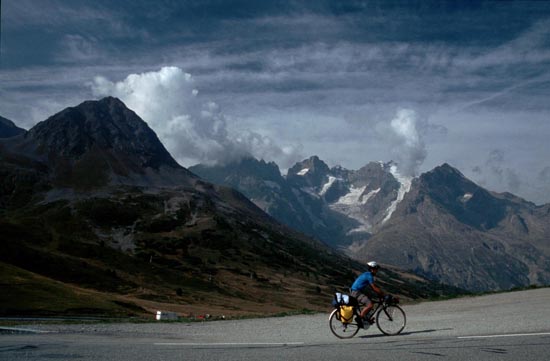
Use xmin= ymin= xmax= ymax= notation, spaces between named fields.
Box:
xmin=0 ymin=288 xmax=550 ymax=361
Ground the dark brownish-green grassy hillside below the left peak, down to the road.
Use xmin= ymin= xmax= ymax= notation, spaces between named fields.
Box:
xmin=0 ymin=187 xmax=470 ymax=316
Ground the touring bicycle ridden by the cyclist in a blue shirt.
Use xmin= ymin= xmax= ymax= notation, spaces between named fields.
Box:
xmin=329 ymin=296 xmax=407 ymax=338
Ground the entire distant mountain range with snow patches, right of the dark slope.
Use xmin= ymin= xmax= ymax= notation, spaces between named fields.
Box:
xmin=192 ymin=156 xmax=550 ymax=291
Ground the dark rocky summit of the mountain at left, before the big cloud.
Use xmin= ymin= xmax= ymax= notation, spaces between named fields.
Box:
xmin=27 ymin=97 xmax=179 ymax=169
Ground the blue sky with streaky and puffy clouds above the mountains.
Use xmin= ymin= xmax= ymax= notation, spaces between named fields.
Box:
xmin=0 ymin=0 xmax=550 ymax=204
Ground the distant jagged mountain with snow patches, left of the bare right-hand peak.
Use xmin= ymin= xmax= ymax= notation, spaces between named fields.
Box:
xmin=189 ymin=156 xmax=410 ymax=249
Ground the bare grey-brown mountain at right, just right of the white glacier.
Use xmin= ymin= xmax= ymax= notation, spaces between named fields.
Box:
xmin=356 ymin=164 xmax=550 ymax=291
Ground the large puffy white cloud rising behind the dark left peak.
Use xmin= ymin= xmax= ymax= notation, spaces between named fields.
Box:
xmin=90 ymin=67 xmax=299 ymax=166
